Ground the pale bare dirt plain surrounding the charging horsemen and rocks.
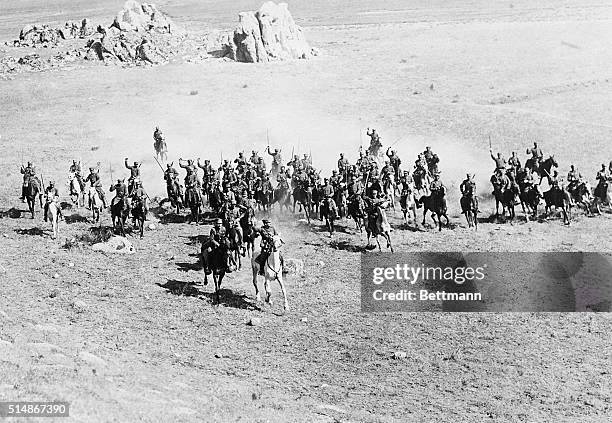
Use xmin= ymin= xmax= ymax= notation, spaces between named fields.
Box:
xmin=0 ymin=0 xmax=612 ymax=422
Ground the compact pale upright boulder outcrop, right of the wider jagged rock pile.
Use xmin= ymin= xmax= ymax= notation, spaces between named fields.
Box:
xmin=225 ymin=1 xmax=317 ymax=63
